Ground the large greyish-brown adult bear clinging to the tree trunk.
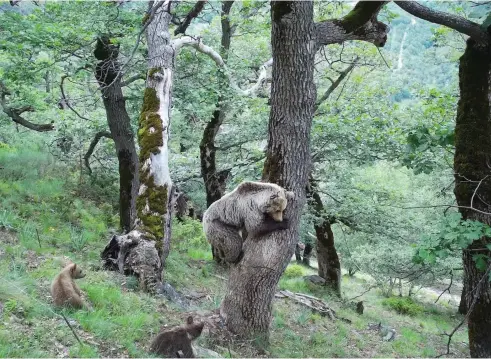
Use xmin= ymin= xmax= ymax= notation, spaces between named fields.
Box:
xmin=203 ymin=181 xmax=295 ymax=263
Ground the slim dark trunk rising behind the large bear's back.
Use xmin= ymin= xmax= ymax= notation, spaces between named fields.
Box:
xmin=199 ymin=1 xmax=234 ymax=263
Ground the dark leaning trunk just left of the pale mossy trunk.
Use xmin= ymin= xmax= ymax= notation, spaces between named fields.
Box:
xmin=94 ymin=35 xmax=139 ymax=233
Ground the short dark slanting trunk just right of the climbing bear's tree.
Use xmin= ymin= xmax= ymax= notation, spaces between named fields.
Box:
xmin=308 ymin=177 xmax=341 ymax=296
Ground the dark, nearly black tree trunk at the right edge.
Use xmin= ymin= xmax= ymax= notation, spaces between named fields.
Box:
xmin=454 ymin=39 xmax=491 ymax=358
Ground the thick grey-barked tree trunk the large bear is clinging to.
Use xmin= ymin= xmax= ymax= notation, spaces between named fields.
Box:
xmin=220 ymin=1 xmax=316 ymax=342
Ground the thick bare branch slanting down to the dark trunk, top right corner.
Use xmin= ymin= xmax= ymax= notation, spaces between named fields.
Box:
xmin=395 ymin=1 xmax=489 ymax=44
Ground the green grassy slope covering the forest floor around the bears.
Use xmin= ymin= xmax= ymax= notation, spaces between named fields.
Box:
xmin=0 ymin=148 xmax=468 ymax=357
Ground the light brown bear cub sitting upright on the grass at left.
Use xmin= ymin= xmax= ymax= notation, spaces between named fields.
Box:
xmin=51 ymin=263 xmax=85 ymax=308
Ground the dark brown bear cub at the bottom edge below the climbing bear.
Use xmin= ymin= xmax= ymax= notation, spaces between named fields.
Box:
xmin=150 ymin=316 xmax=205 ymax=358
